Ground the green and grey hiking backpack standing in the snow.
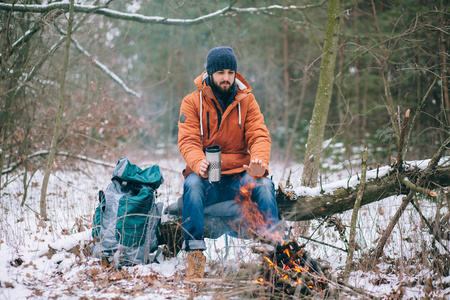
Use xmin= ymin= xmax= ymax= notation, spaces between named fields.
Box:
xmin=92 ymin=158 xmax=164 ymax=267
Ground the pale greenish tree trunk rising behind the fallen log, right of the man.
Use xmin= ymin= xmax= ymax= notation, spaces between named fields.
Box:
xmin=302 ymin=0 xmax=342 ymax=187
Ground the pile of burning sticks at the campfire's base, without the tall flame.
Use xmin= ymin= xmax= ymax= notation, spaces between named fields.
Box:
xmin=244 ymin=229 xmax=328 ymax=295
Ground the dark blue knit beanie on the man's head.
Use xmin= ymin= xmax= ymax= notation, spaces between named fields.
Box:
xmin=206 ymin=47 xmax=237 ymax=75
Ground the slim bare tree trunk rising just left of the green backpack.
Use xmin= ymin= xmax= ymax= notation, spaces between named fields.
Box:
xmin=40 ymin=0 xmax=74 ymax=220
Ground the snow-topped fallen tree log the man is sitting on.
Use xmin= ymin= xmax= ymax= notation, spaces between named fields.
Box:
xmin=160 ymin=162 xmax=450 ymax=253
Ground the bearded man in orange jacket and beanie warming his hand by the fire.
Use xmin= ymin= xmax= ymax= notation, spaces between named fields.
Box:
xmin=178 ymin=47 xmax=279 ymax=279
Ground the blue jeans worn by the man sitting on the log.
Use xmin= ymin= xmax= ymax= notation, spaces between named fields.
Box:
xmin=183 ymin=172 xmax=279 ymax=251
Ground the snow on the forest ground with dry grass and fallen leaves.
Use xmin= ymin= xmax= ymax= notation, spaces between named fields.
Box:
xmin=0 ymin=157 xmax=450 ymax=300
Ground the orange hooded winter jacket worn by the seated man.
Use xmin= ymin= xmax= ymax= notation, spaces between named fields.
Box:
xmin=178 ymin=71 xmax=271 ymax=177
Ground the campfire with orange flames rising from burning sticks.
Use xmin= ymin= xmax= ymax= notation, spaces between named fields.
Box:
xmin=236 ymin=185 xmax=327 ymax=295
